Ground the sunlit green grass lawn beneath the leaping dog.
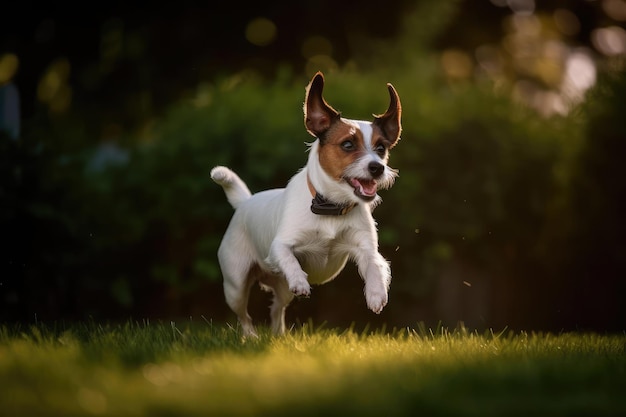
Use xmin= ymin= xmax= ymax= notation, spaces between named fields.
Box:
xmin=0 ymin=322 xmax=626 ymax=417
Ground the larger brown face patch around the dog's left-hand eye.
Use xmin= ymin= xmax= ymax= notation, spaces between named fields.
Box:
xmin=319 ymin=120 xmax=366 ymax=181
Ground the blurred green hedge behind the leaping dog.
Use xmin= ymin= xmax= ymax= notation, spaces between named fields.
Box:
xmin=0 ymin=3 xmax=626 ymax=328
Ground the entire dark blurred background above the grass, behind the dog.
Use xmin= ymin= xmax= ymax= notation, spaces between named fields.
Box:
xmin=0 ymin=0 xmax=626 ymax=331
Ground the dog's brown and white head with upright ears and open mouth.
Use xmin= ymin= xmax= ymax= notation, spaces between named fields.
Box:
xmin=304 ymin=72 xmax=402 ymax=203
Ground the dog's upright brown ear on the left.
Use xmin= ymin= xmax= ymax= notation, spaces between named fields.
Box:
xmin=304 ymin=71 xmax=340 ymax=137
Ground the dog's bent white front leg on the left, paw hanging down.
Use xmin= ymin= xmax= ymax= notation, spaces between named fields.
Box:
xmin=266 ymin=239 xmax=311 ymax=296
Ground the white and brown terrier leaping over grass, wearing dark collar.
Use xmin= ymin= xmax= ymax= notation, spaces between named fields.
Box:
xmin=211 ymin=72 xmax=402 ymax=337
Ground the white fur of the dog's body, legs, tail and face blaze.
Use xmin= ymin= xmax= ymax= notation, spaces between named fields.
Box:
xmin=211 ymin=75 xmax=397 ymax=336
